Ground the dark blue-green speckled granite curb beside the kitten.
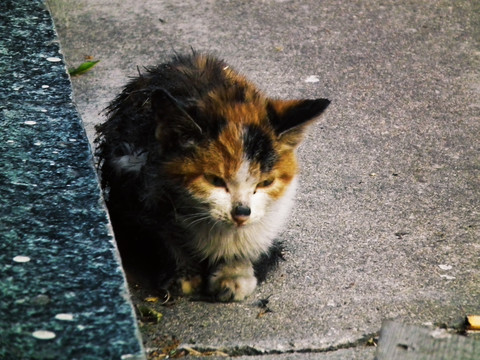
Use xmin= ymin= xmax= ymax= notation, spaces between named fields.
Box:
xmin=0 ymin=0 xmax=144 ymax=360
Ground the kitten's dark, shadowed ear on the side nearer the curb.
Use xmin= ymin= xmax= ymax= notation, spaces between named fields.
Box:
xmin=150 ymin=89 xmax=202 ymax=138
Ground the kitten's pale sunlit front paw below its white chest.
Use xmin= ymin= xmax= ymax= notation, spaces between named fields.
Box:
xmin=209 ymin=262 xmax=257 ymax=302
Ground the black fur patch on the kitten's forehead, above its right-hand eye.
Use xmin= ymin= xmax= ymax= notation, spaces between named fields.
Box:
xmin=243 ymin=125 xmax=278 ymax=173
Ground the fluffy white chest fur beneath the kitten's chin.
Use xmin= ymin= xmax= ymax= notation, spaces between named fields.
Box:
xmin=192 ymin=178 xmax=297 ymax=263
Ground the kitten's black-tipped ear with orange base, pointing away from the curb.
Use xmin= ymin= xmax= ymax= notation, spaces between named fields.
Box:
xmin=267 ymin=99 xmax=330 ymax=148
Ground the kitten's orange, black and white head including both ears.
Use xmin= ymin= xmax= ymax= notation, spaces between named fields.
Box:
xmin=152 ymin=90 xmax=330 ymax=227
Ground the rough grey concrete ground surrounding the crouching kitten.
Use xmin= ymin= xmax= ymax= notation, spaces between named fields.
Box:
xmin=49 ymin=0 xmax=480 ymax=360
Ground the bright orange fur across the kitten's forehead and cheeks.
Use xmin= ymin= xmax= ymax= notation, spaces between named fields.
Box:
xmin=163 ymin=71 xmax=298 ymax=199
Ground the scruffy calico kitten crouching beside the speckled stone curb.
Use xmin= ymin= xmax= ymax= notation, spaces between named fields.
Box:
xmin=96 ymin=53 xmax=330 ymax=301
